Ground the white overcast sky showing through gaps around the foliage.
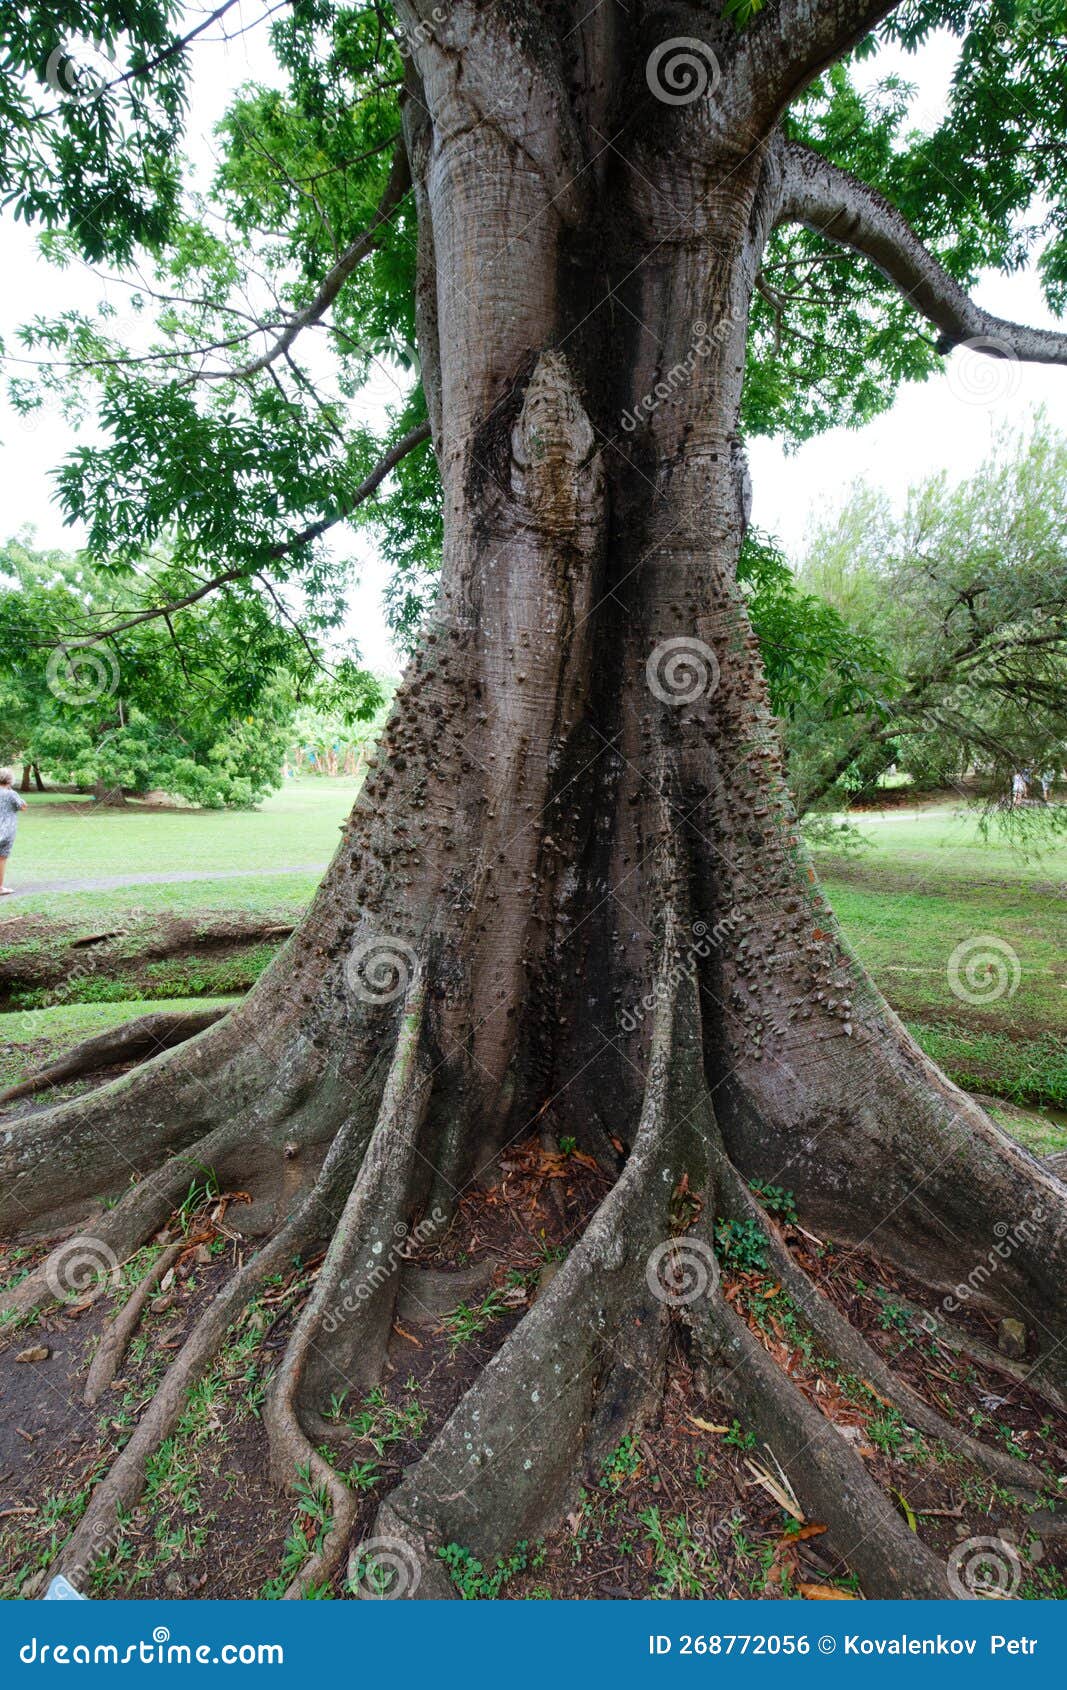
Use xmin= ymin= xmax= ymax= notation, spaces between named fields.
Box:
xmin=0 ymin=16 xmax=1067 ymax=669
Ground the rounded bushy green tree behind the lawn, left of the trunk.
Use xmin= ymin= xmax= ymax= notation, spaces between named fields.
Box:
xmin=0 ymin=541 xmax=382 ymax=810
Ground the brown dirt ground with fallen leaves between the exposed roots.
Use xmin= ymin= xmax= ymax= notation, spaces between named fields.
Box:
xmin=0 ymin=1137 xmax=1067 ymax=1600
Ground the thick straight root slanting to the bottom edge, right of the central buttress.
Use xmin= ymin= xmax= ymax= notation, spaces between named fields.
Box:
xmin=695 ymin=1296 xmax=950 ymax=1597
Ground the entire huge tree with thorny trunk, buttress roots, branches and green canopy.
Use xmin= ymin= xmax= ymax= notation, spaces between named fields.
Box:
xmin=0 ymin=0 xmax=1067 ymax=1595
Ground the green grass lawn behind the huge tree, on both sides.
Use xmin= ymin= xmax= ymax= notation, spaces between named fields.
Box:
xmin=0 ymin=777 xmax=1067 ymax=1149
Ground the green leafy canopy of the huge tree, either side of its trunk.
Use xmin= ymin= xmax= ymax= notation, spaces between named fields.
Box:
xmin=0 ymin=0 xmax=1067 ymax=645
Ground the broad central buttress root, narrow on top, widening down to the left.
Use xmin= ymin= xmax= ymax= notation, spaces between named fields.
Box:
xmin=363 ymin=948 xmax=705 ymax=1595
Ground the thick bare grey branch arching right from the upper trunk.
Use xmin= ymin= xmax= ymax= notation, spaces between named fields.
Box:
xmin=778 ymin=142 xmax=1067 ymax=363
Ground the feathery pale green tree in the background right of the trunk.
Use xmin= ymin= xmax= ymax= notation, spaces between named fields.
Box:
xmin=771 ymin=421 xmax=1067 ymax=818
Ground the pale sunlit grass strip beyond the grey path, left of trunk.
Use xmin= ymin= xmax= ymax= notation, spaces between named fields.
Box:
xmin=8 ymin=777 xmax=360 ymax=885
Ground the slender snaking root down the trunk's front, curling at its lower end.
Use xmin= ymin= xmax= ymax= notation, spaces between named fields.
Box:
xmin=264 ymin=970 xmax=430 ymax=1599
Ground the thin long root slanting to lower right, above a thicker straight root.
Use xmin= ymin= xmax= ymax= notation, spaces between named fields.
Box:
xmin=717 ymin=1158 xmax=1040 ymax=1494
